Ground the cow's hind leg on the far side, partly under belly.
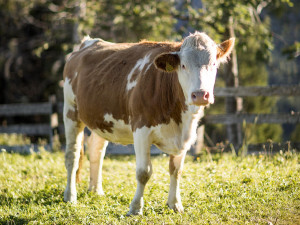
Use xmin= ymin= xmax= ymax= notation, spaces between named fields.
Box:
xmin=88 ymin=132 xmax=108 ymax=195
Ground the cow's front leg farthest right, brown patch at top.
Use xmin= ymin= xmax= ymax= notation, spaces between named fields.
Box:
xmin=167 ymin=151 xmax=186 ymax=213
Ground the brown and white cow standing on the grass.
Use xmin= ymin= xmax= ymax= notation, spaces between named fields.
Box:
xmin=64 ymin=32 xmax=234 ymax=215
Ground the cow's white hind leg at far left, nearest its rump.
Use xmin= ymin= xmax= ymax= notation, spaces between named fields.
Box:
xmin=64 ymin=102 xmax=84 ymax=203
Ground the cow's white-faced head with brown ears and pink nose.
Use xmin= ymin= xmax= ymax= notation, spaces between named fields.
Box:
xmin=155 ymin=32 xmax=234 ymax=106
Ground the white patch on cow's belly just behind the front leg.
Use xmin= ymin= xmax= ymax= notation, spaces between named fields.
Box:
xmin=93 ymin=114 xmax=133 ymax=145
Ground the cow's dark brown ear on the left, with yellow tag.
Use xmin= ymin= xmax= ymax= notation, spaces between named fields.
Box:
xmin=154 ymin=53 xmax=180 ymax=73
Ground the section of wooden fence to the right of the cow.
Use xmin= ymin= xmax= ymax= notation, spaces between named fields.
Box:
xmin=196 ymin=85 xmax=300 ymax=152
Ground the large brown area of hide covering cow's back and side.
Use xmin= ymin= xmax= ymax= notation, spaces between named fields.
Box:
xmin=64 ymin=38 xmax=187 ymax=132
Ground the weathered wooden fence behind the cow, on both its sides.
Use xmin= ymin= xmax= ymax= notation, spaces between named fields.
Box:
xmin=0 ymin=85 xmax=300 ymax=154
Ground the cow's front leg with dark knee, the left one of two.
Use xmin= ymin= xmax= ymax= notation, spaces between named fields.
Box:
xmin=127 ymin=128 xmax=152 ymax=215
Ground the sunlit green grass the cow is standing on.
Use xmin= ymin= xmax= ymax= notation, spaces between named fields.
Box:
xmin=0 ymin=149 xmax=300 ymax=224
